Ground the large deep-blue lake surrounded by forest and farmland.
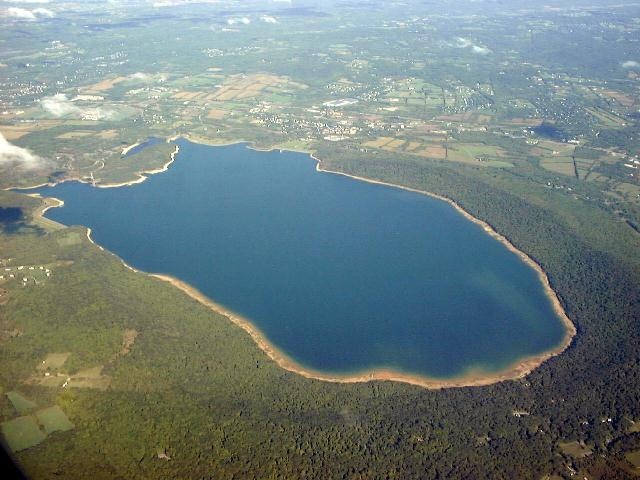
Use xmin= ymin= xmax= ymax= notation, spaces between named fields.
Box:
xmin=32 ymin=141 xmax=564 ymax=377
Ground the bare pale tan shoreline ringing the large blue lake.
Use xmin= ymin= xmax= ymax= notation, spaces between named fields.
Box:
xmin=27 ymin=136 xmax=577 ymax=389
